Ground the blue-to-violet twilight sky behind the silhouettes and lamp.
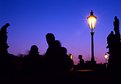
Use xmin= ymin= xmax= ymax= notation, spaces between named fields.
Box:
xmin=0 ymin=0 xmax=121 ymax=64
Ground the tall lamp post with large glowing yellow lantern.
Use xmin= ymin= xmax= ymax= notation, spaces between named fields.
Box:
xmin=87 ymin=11 xmax=97 ymax=64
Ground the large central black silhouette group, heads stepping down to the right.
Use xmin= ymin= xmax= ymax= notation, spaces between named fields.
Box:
xmin=45 ymin=34 xmax=73 ymax=79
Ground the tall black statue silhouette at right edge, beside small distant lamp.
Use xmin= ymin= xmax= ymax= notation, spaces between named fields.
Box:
xmin=107 ymin=16 xmax=121 ymax=74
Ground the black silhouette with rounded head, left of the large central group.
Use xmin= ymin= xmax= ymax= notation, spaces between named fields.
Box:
xmin=22 ymin=45 xmax=43 ymax=77
